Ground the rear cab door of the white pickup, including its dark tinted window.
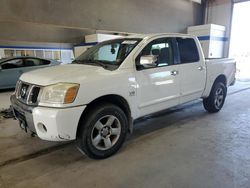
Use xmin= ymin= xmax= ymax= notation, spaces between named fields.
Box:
xmin=176 ymin=38 xmax=206 ymax=103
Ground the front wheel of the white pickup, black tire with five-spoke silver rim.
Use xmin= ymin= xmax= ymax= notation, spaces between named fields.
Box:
xmin=77 ymin=103 xmax=128 ymax=159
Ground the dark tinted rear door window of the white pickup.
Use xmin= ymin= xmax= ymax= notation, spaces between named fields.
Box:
xmin=176 ymin=38 xmax=200 ymax=63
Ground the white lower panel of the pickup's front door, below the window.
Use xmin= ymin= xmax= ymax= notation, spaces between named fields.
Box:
xmin=136 ymin=65 xmax=180 ymax=116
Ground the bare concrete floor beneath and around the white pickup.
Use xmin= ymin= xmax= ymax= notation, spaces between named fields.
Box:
xmin=0 ymin=85 xmax=250 ymax=188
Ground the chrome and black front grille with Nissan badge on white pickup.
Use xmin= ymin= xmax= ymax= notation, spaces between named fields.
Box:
xmin=16 ymin=81 xmax=40 ymax=105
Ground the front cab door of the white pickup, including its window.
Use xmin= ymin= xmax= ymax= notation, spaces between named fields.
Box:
xmin=136 ymin=38 xmax=180 ymax=116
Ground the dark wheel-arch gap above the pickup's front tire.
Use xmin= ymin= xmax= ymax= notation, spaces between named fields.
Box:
xmin=76 ymin=94 xmax=133 ymax=136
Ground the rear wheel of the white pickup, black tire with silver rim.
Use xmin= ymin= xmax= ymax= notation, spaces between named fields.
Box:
xmin=203 ymin=82 xmax=227 ymax=113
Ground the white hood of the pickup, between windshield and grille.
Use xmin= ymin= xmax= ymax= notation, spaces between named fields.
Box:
xmin=20 ymin=64 xmax=110 ymax=86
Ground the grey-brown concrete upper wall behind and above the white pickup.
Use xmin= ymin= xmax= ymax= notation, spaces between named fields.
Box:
xmin=0 ymin=0 xmax=203 ymax=43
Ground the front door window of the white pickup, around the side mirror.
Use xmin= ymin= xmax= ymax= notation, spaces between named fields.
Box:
xmin=136 ymin=38 xmax=174 ymax=69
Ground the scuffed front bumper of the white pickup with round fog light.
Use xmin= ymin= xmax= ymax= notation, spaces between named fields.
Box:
xmin=11 ymin=95 xmax=86 ymax=141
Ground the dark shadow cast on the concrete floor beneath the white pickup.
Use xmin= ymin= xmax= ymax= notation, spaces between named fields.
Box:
xmin=0 ymin=101 xmax=209 ymax=169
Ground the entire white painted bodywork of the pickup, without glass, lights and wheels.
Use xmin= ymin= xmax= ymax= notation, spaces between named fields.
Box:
xmin=17 ymin=34 xmax=235 ymax=141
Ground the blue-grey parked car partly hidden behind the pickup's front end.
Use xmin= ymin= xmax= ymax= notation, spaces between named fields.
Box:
xmin=0 ymin=56 xmax=61 ymax=89
